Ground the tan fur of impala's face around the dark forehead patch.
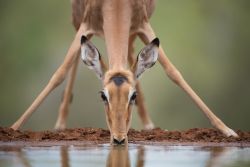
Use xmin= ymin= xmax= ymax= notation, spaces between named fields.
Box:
xmin=103 ymin=70 xmax=135 ymax=142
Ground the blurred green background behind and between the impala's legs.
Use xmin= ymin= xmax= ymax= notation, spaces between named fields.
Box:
xmin=0 ymin=0 xmax=250 ymax=130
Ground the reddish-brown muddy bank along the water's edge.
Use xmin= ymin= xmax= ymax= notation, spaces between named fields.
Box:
xmin=0 ymin=127 xmax=250 ymax=145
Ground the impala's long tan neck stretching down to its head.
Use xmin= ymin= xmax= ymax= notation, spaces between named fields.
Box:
xmin=103 ymin=0 xmax=131 ymax=70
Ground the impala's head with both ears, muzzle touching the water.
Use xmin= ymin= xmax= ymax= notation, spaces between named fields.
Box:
xmin=81 ymin=36 xmax=159 ymax=144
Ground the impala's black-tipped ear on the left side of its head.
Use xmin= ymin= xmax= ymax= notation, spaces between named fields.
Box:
xmin=81 ymin=36 xmax=104 ymax=79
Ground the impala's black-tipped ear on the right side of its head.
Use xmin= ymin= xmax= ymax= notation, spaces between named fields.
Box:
xmin=132 ymin=38 xmax=160 ymax=79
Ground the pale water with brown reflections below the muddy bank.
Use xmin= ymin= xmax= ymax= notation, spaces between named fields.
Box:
xmin=0 ymin=144 xmax=250 ymax=167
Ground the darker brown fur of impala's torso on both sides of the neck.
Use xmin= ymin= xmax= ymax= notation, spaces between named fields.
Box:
xmin=71 ymin=0 xmax=155 ymax=32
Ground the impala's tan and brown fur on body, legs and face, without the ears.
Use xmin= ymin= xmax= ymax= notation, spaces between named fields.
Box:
xmin=12 ymin=0 xmax=238 ymax=142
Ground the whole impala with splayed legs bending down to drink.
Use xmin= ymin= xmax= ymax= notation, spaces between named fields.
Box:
xmin=12 ymin=0 xmax=237 ymax=144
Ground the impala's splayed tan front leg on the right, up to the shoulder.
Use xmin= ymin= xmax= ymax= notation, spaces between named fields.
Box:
xmin=139 ymin=23 xmax=238 ymax=137
